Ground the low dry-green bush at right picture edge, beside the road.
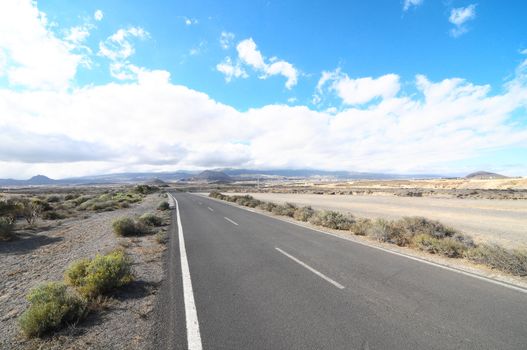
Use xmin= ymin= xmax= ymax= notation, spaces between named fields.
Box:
xmin=465 ymin=244 xmax=527 ymax=276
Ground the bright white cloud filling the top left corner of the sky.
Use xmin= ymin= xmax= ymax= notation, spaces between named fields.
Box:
xmin=0 ymin=0 xmax=82 ymax=89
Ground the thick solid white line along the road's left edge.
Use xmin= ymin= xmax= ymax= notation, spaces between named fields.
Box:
xmin=171 ymin=195 xmax=202 ymax=350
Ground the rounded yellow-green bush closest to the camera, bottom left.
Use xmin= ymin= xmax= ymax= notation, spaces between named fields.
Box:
xmin=19 ymin=282 xmax=86 ymax=337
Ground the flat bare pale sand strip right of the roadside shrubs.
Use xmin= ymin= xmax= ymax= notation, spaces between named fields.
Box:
xmin=238 ymin=193 xmax=527 ymax=248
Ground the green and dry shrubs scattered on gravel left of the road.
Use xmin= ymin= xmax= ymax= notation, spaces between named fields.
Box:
xmin=10 ymin=190 xmax=170 ymax=338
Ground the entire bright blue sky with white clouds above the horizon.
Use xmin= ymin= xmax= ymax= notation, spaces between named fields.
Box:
xmin=0 ymin=0 xmax=527 ymax=177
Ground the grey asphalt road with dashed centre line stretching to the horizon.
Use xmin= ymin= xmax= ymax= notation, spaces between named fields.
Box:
xmin=153 ymin=193 xmax=527 ymax=350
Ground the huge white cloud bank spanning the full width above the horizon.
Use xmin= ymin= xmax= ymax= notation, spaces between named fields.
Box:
xmin=0 ymin=56 xmax=527 ymax=177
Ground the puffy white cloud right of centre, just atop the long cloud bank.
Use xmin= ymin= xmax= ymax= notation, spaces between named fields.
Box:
xmin=314 ymin=69 xmax=401 ymax=105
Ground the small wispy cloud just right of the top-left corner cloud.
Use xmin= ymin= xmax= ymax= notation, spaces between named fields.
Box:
xmin=98 ymin=27 xmax=149 ymax=80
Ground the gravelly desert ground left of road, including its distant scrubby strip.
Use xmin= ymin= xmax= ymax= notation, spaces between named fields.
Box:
xmin=0 ymin=186 xmax=170 ymax=349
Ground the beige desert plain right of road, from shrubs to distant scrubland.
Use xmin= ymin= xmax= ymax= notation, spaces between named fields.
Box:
xmin=225 ymin=179 xmax=527 ymax=248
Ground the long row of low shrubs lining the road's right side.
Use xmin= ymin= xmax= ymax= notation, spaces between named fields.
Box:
xmin=209 ymin=191 xmax=527 ymax=277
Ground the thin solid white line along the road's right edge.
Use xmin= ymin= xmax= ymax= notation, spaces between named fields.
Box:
xmin=200 ymin=194 xmax=527 ymax=294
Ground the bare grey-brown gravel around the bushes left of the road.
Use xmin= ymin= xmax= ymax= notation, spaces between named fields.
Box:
xmin=0 ymin=194 xmax=169 ymax=349
